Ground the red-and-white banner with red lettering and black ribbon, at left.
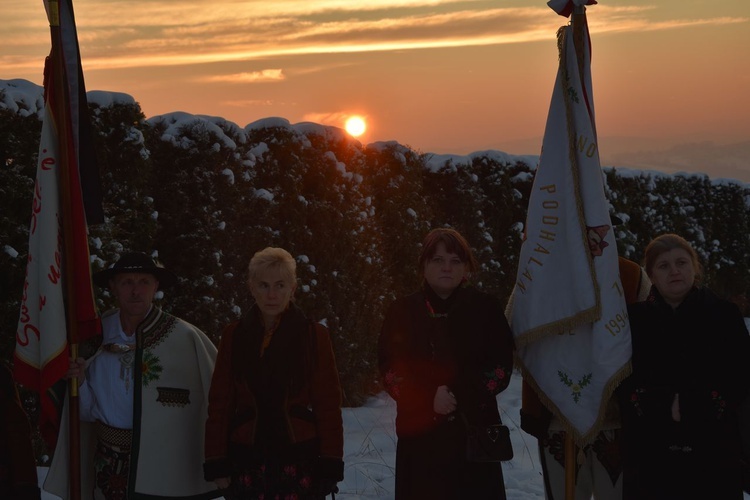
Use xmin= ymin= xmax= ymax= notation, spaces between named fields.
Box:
xmin=14 ymin=0 xmax=102 ymax=445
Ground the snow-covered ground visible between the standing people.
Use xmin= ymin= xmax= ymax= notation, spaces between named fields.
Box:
xmin=39 ymin=373 xmax=750 ymax=500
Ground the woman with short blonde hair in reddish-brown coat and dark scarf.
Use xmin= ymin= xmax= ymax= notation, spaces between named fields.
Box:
xmin=204 ymin=248 xmax=344 ymax=500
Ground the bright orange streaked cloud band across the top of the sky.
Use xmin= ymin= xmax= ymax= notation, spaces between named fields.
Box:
xmin=0 ymin=0 xmax=750 ymax=76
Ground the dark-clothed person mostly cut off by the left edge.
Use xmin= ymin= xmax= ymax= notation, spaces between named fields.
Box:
xmin=0 ymin=364 xmax=41 ymax=500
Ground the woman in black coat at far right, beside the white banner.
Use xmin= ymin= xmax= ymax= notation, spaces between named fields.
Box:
xmin=618 ymin=234 xmax=750 ymax=500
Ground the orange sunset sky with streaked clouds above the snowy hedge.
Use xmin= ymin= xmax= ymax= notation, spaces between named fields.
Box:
xmin=0 ymin=0 xmax=750 ymax=181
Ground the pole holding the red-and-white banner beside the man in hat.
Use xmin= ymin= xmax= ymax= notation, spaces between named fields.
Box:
xmin=48 ymin=0 xmax=81 ymax=500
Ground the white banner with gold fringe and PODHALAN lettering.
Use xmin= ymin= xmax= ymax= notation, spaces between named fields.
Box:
xmin=508 ymin=15 xmax=631 ymax=445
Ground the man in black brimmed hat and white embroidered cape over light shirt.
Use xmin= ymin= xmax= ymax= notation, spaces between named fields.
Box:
xmin=44 ymin=253 xmax=220 ymax=500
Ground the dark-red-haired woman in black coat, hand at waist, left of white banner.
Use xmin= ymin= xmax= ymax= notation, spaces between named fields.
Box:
xmin=379 ymin=229 xmax=513 ymax=500
